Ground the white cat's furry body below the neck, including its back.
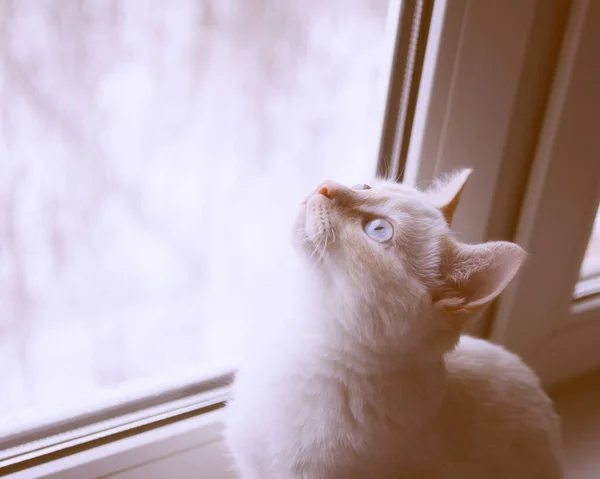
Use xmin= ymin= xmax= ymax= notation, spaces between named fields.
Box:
xmin=229 ymin=337 xmax=561 ymax=479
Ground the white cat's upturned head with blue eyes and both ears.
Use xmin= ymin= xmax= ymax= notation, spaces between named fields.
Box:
xmin=296 ymin=170 xmax=525 ymax=358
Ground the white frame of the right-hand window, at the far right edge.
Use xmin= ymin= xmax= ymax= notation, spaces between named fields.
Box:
xmin=494 ymin=0 xmax=600 ymax=384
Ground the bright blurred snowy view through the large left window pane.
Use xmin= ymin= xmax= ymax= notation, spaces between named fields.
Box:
xmin=0 ymin=0 xmax=387 ymax=436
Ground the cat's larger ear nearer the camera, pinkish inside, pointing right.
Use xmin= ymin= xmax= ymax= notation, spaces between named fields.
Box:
xmin=433 ymin=238 xmax=525 ymax=328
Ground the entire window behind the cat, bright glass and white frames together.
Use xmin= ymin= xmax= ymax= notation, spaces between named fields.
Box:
xmin=0 ymin=0 xmax=600 ymax=477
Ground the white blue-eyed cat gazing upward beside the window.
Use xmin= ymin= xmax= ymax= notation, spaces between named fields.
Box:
xmin=226 ymin=170 xmax=562 ymax=479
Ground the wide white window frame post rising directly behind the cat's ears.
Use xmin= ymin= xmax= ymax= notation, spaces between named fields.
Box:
xmin=405 ymin=0 xmax=569 ymax=342
